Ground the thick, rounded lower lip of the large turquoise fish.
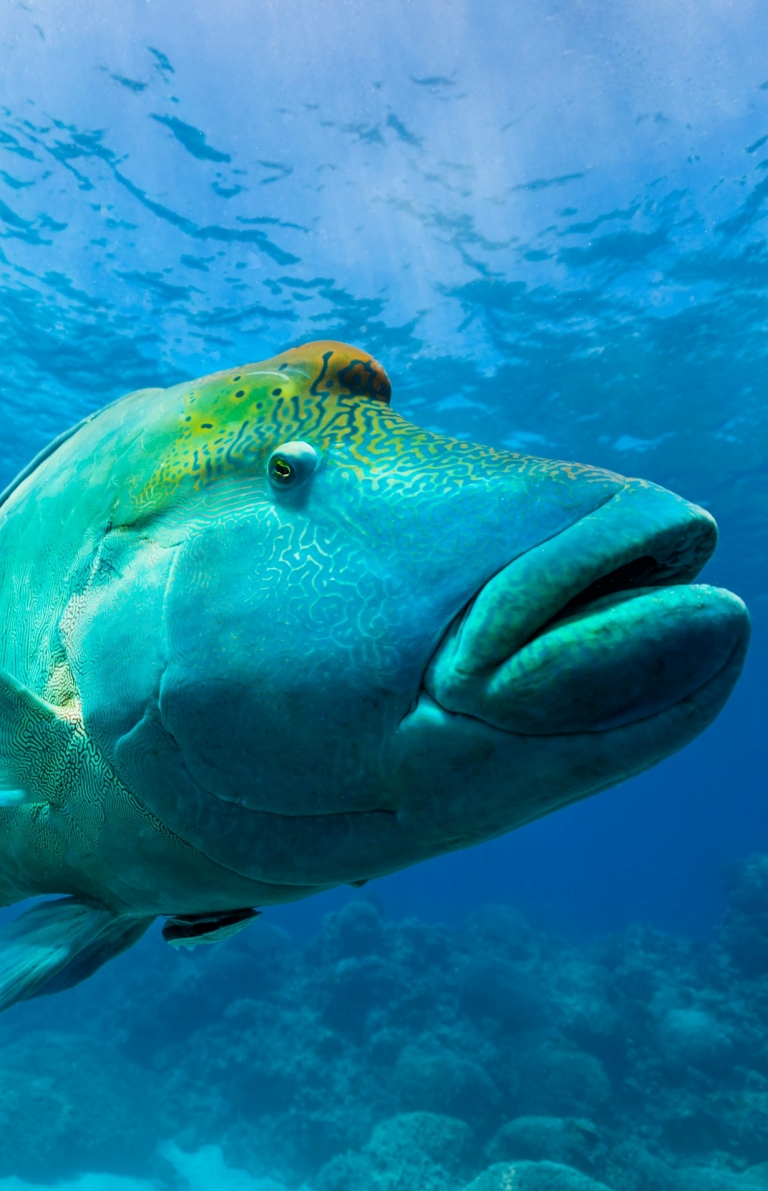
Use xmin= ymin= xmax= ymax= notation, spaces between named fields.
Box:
xmin=440 ymin=585 xmax=749 ymax=736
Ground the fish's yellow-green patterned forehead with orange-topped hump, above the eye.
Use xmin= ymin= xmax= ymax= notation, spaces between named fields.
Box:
xmin=112 ymin=341 xmax=619 ymax=522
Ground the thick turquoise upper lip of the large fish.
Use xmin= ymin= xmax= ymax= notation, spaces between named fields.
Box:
xmin=423 ymin=480 xmax=717 ymax=711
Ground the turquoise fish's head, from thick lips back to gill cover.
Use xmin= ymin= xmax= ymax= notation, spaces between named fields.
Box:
xmin=68 ymin=342 xmax=749 ymax=887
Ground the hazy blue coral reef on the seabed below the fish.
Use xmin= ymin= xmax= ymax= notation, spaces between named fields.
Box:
xmin=0 ymin=856 xmax=768 ymax=1191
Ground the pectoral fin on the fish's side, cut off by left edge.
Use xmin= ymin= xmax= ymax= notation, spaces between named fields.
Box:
xmin=0 ymin=667 xmax=75 ymax=802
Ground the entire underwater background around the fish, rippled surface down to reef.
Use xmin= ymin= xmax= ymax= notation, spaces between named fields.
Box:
xmin=0 ymin=0 xmax=768 ymax=1191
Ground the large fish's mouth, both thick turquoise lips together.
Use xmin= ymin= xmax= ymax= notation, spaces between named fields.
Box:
xmin=424 ymin=481 xmax=749 ymax=735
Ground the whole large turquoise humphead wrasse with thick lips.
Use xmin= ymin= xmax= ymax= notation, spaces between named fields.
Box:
xmin=0 ymin=341 xmax=749 ymax=1009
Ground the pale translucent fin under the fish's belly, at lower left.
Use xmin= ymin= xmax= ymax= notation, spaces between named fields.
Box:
xmin=0 ymin=897 xmax=155 ymax=1011
